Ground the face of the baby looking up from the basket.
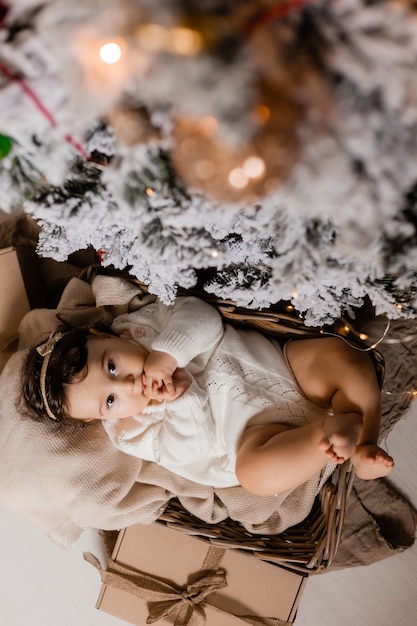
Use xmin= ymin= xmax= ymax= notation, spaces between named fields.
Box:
xmin=66 ymin=337 xmax=151 ymax=420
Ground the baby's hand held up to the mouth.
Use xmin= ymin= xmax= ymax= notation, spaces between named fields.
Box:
xmin=142 ymin=350 xmax=177 ymax=400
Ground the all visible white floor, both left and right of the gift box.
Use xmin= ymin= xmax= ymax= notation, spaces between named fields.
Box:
xmin=0 ymin=401 xmax=417 ymax=626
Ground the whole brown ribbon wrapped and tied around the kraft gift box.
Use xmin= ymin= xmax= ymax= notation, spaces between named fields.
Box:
xmin=84 ymin=546 xmax=288 ymax=626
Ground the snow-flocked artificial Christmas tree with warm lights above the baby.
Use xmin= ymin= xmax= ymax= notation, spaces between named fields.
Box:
xmin=0 ymin=0 xmax=417 ymax=325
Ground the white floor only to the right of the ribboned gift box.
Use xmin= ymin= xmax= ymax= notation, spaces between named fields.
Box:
xmin=295 ymin=403 xmax=417 ymax=626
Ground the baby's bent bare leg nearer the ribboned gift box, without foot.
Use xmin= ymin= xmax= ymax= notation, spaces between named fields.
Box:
xmin=236 ymin=418 xmax=329 ymax=496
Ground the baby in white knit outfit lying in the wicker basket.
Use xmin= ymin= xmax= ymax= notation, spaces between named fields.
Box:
xmin=23 ymin=297 xmax=394 ymax=495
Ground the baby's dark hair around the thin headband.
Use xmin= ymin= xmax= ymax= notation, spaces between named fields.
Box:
xmin=22 ymin=329 xmax=89 ymax=422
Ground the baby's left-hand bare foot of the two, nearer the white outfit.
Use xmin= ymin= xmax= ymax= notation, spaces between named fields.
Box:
xmin=319 ymin=413 xmax=363 ymax=463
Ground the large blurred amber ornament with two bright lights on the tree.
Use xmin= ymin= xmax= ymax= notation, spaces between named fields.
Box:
xmin=171 ymin=78 xmax=301 ymax=203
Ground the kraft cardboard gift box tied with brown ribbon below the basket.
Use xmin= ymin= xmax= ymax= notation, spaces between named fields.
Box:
xmin=90 ymin=522 xmax=306 ymax=626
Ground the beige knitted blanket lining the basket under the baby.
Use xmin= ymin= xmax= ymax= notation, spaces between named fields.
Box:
xmin=0 ymin=276 xmax=318 ymax=546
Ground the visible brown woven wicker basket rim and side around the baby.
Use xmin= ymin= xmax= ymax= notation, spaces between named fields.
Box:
xmin=153 ymin=292 xmax=384 ymax=574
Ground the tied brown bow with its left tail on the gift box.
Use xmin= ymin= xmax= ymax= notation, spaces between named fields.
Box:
xmin=84 ymin=551 xmax=227 ymax=626
